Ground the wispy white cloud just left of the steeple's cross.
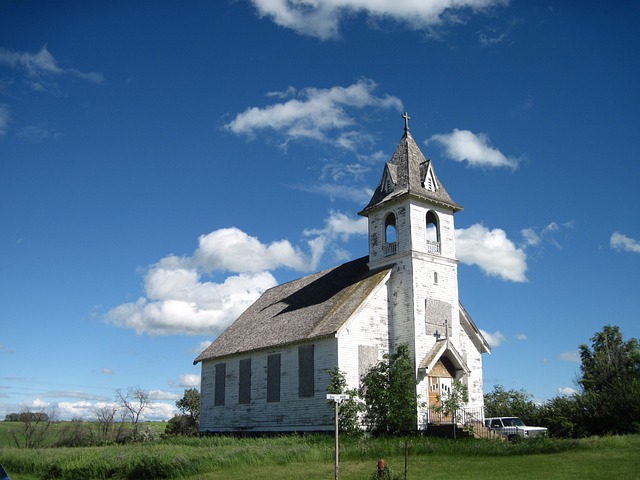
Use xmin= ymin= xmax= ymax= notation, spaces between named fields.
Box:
xmin=225 ymin=79 xmax=402 ymax=150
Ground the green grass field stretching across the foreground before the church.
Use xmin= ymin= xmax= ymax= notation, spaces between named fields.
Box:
xmin=0 ymin=422 xmax=640 ymax=480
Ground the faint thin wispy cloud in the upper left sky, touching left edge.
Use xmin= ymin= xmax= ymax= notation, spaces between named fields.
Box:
xmin=0 ymin=45 xmax=104 ymax=86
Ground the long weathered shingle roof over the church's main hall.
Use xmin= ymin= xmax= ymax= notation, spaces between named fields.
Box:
xmin=193 ymin=257 xmax=390 ymax=365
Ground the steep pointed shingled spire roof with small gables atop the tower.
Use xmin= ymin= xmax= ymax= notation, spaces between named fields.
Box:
xmin=360 ymin=128 xmax=463 ymax=216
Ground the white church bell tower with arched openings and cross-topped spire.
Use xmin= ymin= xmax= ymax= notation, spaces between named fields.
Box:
xmin=360 ymin=113 xmax=462 ymax=380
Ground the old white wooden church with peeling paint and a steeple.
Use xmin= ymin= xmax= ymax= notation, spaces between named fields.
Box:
xmin=194 ymin=114 xmax=490 ymax=433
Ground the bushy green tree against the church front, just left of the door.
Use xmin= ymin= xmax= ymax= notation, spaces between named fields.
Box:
xmin=360 ymin=344 xmax=417 ymax=434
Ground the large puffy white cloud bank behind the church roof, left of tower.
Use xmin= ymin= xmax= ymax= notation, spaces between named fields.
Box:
xmin=104 ymin=212 xmax=366 ymax=336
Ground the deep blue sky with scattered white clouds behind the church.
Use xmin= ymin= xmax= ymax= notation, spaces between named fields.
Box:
xmin=0 ymin=0 xmax=640 ymax=419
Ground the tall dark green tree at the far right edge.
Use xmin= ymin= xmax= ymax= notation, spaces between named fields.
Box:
xmin=578 ymin=325 xmax=640 ymax=435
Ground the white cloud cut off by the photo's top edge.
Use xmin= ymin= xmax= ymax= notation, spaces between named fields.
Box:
xmin=252 ymin=0 xmax=508 ymax=40
